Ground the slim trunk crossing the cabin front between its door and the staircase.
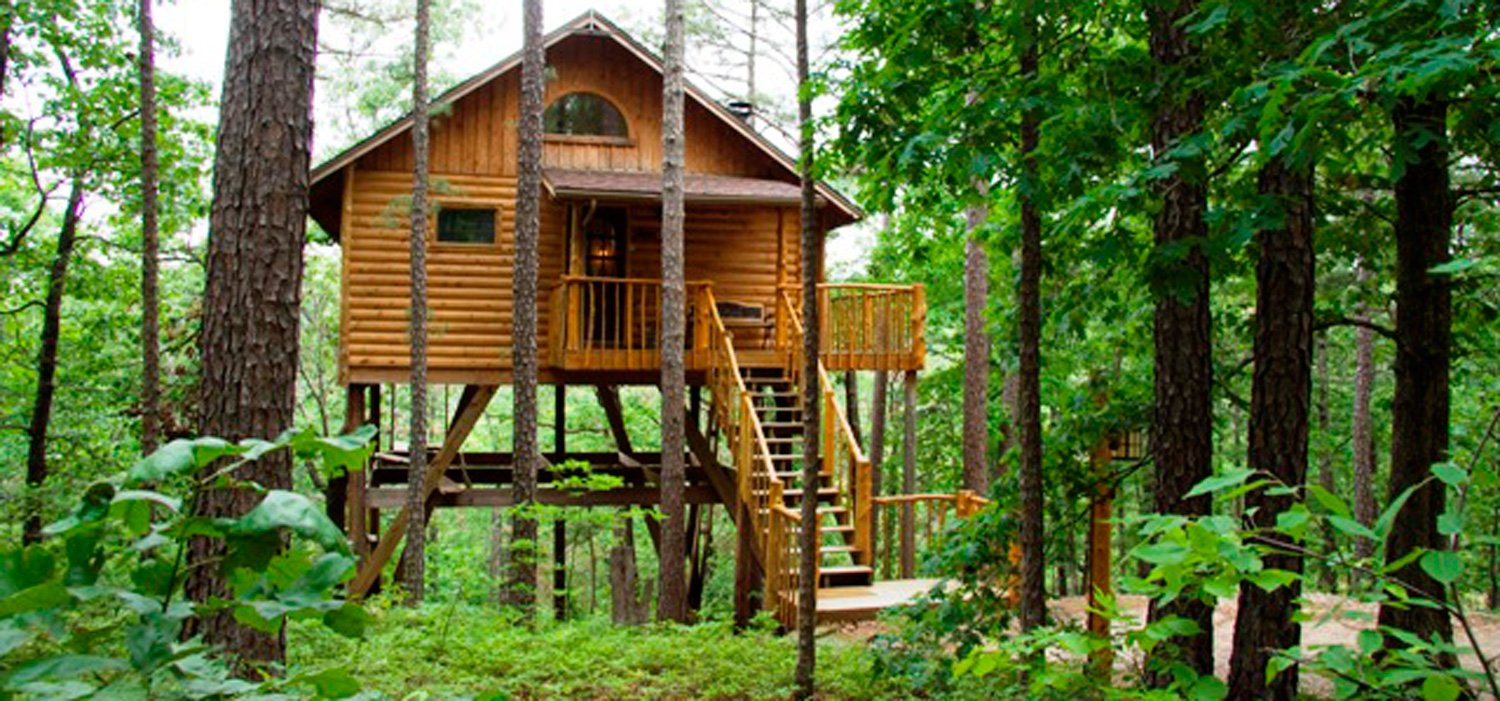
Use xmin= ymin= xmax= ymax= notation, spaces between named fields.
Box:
xmin=657 ymin=0 xmax=687 ymax=623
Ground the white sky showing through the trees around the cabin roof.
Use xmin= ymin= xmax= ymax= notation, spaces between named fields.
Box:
xmin=158 ymin=0 xmax=873 ymax=276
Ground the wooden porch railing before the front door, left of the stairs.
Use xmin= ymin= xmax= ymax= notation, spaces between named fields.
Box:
xmin=549 ymin=275 xmax=713 ymax=371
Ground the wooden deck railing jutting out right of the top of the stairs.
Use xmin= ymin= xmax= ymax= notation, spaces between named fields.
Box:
xmin=777 ymin=284 xmax=927 ymax=371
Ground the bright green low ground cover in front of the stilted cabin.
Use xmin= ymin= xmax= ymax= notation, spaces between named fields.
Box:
xmin=288 ymin=603 xmax=887 ymax=699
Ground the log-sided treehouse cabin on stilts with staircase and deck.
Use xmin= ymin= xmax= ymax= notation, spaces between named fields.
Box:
xmin=311 ymin=14 xmax=962 ymax=620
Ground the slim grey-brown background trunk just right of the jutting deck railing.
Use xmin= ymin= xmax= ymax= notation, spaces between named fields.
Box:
xmin=963 ymin=217 xmax=990 ymax=494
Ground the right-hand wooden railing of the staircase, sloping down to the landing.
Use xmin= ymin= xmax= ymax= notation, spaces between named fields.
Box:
xmin=777 ymin=288 xmax=875 ymax=566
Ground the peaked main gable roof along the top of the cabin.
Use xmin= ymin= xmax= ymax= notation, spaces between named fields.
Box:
xmin=311 ymin=11 xmax=864 ymax=221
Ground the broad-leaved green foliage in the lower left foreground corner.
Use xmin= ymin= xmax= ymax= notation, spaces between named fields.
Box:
xmin=0 ymin=428 xmax=374 ymax=698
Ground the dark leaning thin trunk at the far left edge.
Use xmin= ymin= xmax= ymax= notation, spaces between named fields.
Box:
xmin=21 ymin=174 xmax=84 ymax=545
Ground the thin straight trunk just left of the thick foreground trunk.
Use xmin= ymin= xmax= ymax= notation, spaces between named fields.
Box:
xmin=138 ymin=0 xmax=162 ymax=455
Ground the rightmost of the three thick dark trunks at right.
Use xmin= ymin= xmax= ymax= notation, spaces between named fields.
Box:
xmin=1379 ymin=98 xmax=1454 ymax=641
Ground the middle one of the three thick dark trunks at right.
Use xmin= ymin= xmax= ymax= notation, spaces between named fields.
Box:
xmin=1229 ymin=156 xmax=1316 ymax=701
